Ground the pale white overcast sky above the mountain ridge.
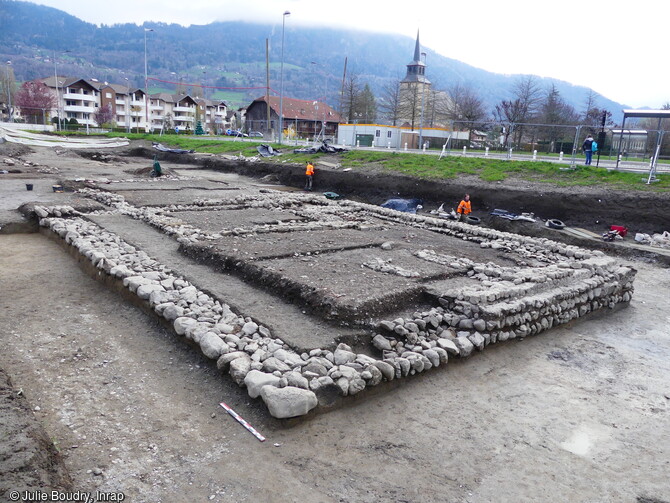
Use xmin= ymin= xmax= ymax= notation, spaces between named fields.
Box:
xmin=28 ymin=0 xmax=670 ymax=108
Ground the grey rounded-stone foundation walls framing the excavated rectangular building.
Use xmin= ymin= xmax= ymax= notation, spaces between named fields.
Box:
xmin=35 ymin=189 xmax=635 ymax=418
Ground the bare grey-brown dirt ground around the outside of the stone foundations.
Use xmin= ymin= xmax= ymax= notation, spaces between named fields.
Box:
xmin=0 ymin=143 xmax=670 ymax=503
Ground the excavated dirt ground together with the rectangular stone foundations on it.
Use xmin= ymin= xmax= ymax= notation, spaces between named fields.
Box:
xmin=0 ymin=141 xmax=670 ymax=502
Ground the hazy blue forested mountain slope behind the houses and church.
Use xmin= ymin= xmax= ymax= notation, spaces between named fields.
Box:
xmin=0 ymin=0 xmax=623 ymax=120
